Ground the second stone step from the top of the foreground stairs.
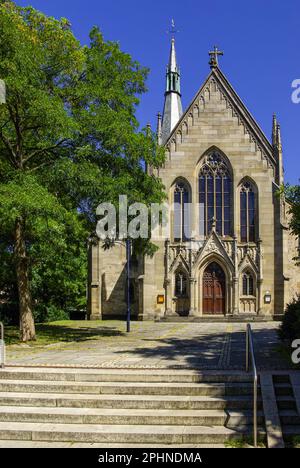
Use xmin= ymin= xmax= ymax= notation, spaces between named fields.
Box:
xmin=0 ymin=379 xmax=258 ymax=396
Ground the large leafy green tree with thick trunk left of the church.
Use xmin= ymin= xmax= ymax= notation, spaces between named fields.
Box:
xmin=0 ymin=2 xmax=164 ymax=341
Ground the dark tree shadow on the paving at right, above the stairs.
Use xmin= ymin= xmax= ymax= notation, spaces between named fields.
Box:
xmin=116 ymin=329 xmax=293 ymax=370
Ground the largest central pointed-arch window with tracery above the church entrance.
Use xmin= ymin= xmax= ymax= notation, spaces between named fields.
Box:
xmin=199 ymin=151 xmax=232 ymax=236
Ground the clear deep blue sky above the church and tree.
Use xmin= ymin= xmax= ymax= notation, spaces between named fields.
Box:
xmin=16 ymin=0 xmax=300 ymax=183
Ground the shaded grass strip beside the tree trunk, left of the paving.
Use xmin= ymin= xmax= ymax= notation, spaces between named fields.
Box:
xmin=5 ymin=320 xmax=125 ymax=347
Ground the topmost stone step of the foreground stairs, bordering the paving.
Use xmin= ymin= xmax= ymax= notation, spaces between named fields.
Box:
xmin=0 ymin=368 xmax=253 ymax=383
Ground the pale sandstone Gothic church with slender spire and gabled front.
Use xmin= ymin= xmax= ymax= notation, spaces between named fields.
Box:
xmin=88 ymin=37 xmax=300 ymax=321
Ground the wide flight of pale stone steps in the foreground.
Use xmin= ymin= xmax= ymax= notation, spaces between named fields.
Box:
xmin=0 ymin=368 xmax=264 ymax=447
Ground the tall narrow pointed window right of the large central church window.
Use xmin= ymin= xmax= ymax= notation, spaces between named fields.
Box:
xmin=240 ymin=181 xmax=256 ymax=242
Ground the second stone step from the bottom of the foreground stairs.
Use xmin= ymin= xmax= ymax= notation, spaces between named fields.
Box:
xmin=0 ymin=406 xmax=263 ymax=428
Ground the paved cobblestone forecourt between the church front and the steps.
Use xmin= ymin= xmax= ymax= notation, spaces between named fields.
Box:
xmin=6 ymin=321 xmax=288 ymax=370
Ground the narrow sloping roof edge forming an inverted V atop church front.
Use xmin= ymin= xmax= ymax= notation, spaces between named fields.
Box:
xmin=164 ymin=67 xmax=276 ymax=166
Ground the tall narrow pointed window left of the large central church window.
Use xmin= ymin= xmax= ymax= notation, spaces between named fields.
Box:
xmin=174 ymin=181 xmax=191 ymax=242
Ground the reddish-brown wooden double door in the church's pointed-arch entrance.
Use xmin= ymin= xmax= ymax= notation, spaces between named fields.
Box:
xmin=202 ymin=262 xmax=226 ymax=315
